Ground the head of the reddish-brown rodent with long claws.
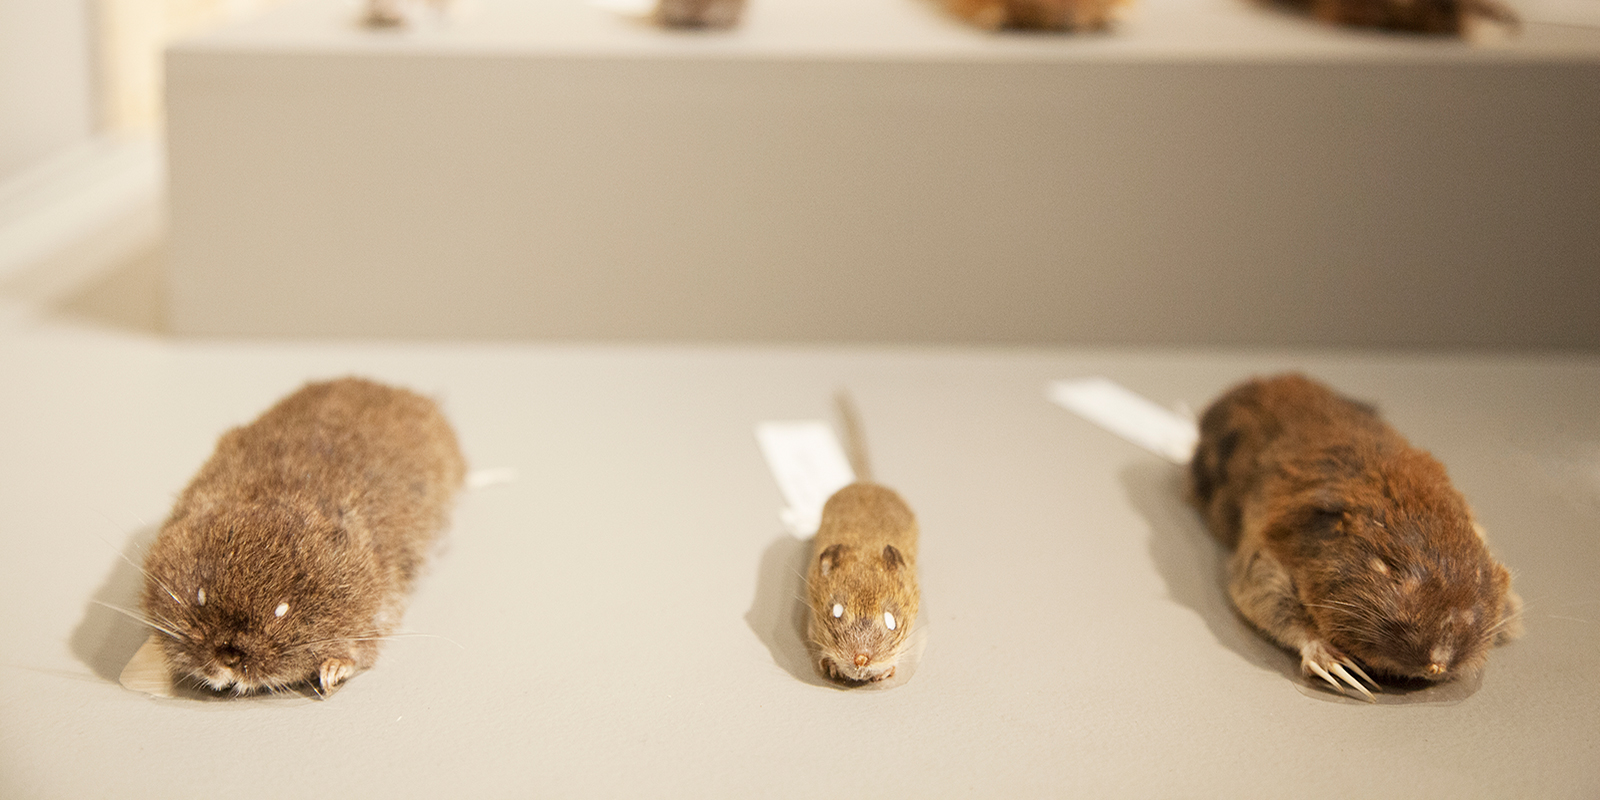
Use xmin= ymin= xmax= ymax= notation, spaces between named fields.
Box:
xmin=1310 ymin=520 xmax=1518 ymax=682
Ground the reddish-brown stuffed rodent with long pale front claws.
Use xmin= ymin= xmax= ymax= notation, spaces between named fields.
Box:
xmin=1190 ymin=374 xmax=1522 ymax=699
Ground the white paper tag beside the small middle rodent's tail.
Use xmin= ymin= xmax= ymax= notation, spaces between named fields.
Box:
xmin=755 ymin=419 xmax=856 ymax=539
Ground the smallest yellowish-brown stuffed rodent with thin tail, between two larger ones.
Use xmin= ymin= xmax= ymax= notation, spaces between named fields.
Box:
xmin=806 ymin=395 xmax=920 ymax=683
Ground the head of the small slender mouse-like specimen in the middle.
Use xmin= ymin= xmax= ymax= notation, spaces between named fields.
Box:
xmin=808 ymin=544 xmax=917 ymax=683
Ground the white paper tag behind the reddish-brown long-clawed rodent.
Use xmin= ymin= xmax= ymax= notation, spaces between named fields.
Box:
xmin=1045 ymin=378 xmax=1200 ymax=464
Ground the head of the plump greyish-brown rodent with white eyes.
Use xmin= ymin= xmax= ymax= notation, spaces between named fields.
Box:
xmin=142 ymin=504 xmax=378 ymax=694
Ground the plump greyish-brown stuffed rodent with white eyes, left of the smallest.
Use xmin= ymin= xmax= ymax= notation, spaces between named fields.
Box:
xmin=142 ymin=378 xmax=466 ymax=694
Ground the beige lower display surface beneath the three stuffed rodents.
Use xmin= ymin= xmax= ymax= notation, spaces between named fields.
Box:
xmin=0 ymin=318 xmax=1600 ymax=798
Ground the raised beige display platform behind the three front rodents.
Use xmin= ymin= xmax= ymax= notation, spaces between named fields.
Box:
xmin=166 ymin=0 xmax=1600 ymax=347
